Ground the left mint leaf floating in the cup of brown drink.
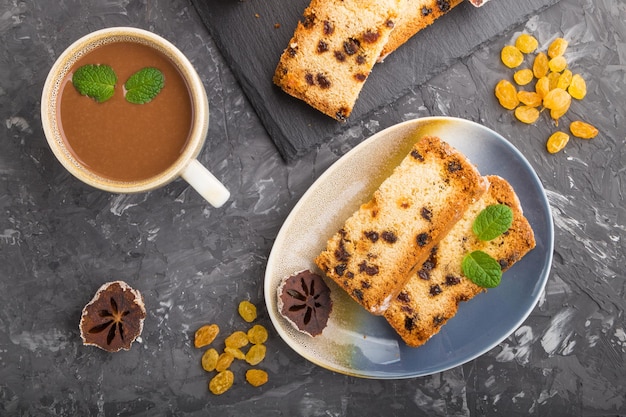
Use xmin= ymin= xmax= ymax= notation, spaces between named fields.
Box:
xmin=72 ymin=64 xmax=117 ymax=103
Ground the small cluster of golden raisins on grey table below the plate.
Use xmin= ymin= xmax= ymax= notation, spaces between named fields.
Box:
xmin=194 ymin=301 xmax=268 ymax=395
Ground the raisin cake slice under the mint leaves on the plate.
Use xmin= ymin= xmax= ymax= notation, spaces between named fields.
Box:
xmin=384 ymin=176 xmax=535 ymax=347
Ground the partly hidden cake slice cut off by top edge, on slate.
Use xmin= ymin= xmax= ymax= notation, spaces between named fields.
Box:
xmin=380 ymin=0 xmax=463 ymax=60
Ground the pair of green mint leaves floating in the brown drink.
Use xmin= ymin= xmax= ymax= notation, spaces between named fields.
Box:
xmin=72 ymin=64 xmax=165 ymax=104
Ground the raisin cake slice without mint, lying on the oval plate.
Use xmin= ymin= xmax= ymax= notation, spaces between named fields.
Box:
xmin=315 ymin=136 xmax=487 ymax=315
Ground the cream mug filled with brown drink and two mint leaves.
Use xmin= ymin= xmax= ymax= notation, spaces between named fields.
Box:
xmin=41 ymin=27 xmax=230 ymax=207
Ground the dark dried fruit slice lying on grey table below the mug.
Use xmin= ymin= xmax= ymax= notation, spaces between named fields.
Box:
xmin=80 ymin=281 xmax=146 ymax=352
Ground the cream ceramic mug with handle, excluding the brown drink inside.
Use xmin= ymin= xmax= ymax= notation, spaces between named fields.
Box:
xmin=41 ymin=27 xmax=230 ymax=207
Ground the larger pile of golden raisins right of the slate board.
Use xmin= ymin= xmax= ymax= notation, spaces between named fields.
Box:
xmin=495 ymin=33 xmax=598 ymax=153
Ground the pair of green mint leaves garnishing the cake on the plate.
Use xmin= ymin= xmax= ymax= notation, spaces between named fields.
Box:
xmin=461 ymin=204 xmax=513 ymax=288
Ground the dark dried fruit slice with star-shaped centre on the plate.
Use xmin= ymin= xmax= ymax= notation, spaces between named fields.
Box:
xmin=278 ymin=270 xmax=332 ymax=336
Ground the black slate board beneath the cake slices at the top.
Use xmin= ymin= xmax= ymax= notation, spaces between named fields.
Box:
xmin=192 ymin=0 xmax=559 ymax=161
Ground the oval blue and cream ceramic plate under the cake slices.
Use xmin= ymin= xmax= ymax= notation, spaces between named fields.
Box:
xmin=265 ymin=117 xmax=554 ymax=379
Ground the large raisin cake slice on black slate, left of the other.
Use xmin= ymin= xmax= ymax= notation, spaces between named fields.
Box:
xmin=274 ymin=0 xmax=400 ymax=121
